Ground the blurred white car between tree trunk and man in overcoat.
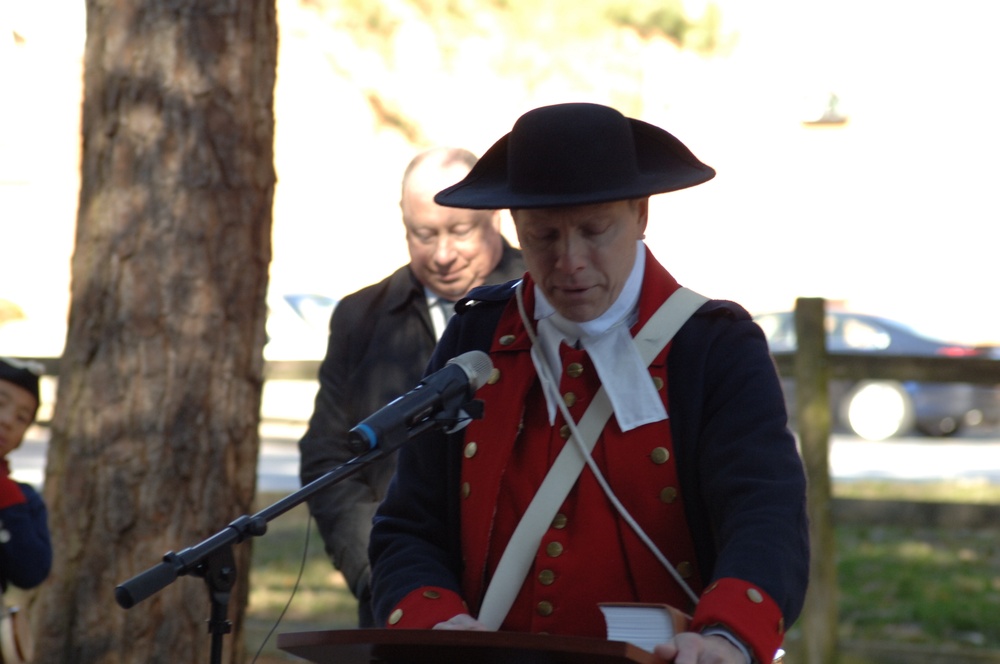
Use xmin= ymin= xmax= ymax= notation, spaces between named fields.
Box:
xmin=264 ymin=293 xmax=339 ymax=361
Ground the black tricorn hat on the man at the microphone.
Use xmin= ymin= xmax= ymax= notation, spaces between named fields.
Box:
xmin=434 ymin=103 xmax=715 ymax=210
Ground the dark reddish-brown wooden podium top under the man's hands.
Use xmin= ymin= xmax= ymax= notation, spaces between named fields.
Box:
xmin=278 ymin=629 xmax=658 ymax=664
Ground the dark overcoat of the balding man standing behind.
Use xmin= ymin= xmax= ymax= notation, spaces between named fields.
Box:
xmin=299 ymin=241 xmax=524 ymax=626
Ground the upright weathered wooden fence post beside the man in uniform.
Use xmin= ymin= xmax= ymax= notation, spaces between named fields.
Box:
xmin=795 ymin=298 xmax=838 ymax=664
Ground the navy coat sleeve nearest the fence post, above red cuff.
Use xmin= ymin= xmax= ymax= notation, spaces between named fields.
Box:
xmin=667 ymin=302 xmax=809 ymax=625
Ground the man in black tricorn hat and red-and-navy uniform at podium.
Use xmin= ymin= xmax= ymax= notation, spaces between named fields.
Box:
xmin=370 ymin=104 xmax=809 ymax=664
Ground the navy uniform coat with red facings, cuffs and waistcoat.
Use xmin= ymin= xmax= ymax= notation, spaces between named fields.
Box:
xmin=372 ymin=250 xmax=808 ymax=661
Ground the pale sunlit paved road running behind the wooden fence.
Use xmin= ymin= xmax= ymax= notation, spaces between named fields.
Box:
xmin=10 ymin=422 xmax=1000 ymax=493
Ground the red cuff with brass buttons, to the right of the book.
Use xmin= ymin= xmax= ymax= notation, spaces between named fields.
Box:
xmin=691 ymin=578 xmax=785 ymax=664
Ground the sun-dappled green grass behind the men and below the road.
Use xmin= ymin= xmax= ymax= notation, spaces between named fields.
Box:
xmin=246 ymin=482 xmax=1000 ymax=664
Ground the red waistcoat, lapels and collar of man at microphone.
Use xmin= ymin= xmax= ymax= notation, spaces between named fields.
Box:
xmin=460 ymin=253 xmax=702 ymax=636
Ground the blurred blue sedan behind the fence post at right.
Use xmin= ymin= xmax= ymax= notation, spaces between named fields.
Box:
xmin=754 ymin=311 xmax=1000 ymax=440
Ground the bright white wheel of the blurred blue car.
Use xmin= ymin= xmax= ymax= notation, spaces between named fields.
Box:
xmin=841 ymin=381 xmax=914 ymax=440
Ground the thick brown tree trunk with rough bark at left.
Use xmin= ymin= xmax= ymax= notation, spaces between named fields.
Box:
xmin=30 ymin=0 xmax=277 ymax=664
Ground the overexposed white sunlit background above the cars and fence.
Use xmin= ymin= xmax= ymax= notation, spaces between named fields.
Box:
xmin=0 ymin=0 xmax=1000 ymax=355
